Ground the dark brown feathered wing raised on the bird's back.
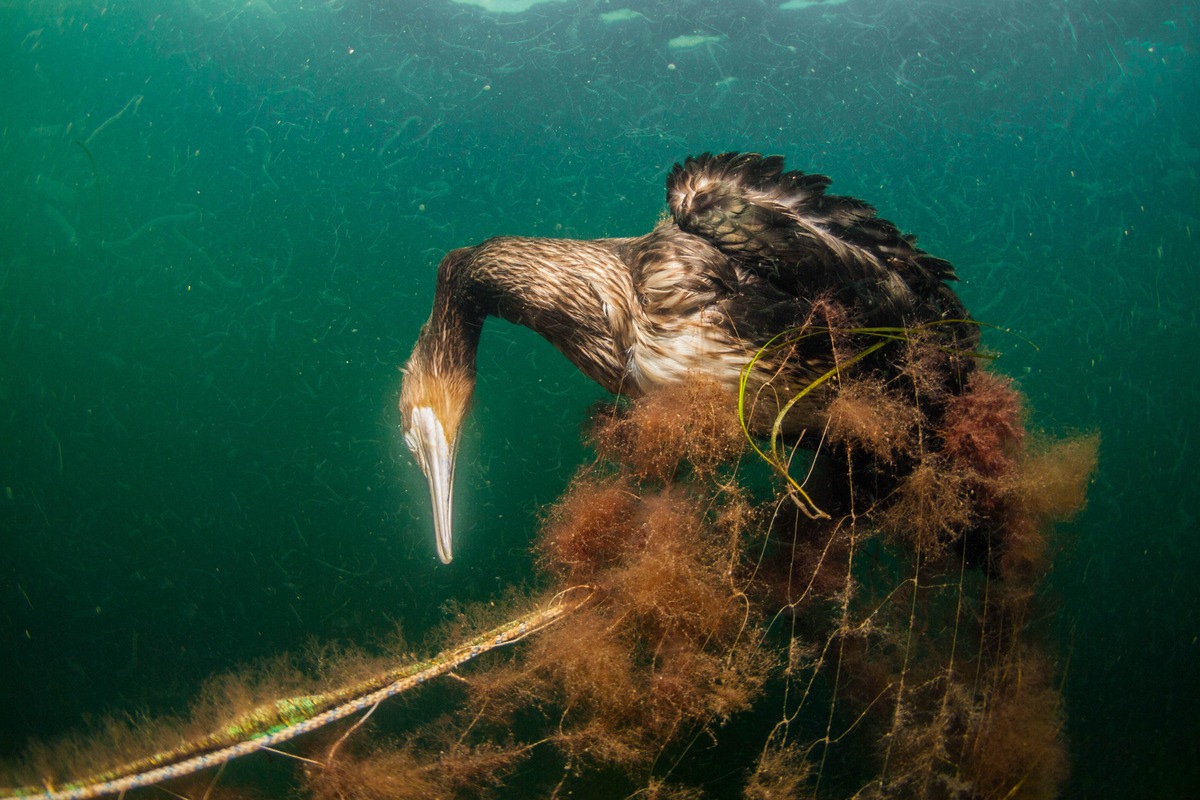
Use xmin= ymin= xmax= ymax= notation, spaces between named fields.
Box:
xmin=667 ymin=152 xmax=965 ymax=320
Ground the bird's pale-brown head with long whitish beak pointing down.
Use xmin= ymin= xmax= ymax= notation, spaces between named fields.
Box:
xmin=400 ymin=336 xmax=475 ymax=564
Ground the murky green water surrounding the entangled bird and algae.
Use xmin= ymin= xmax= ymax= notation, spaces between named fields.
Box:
xmin=0 ymin=0 xmax=1200 ymax=798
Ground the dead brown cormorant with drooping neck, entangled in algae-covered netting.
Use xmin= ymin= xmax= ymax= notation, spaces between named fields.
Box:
xmin=400 ymin=152 xmax=978 ymax=564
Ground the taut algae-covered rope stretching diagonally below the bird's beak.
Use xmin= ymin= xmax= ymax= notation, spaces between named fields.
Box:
xmin=0 ymin=587 xmax=590 ymax=800
